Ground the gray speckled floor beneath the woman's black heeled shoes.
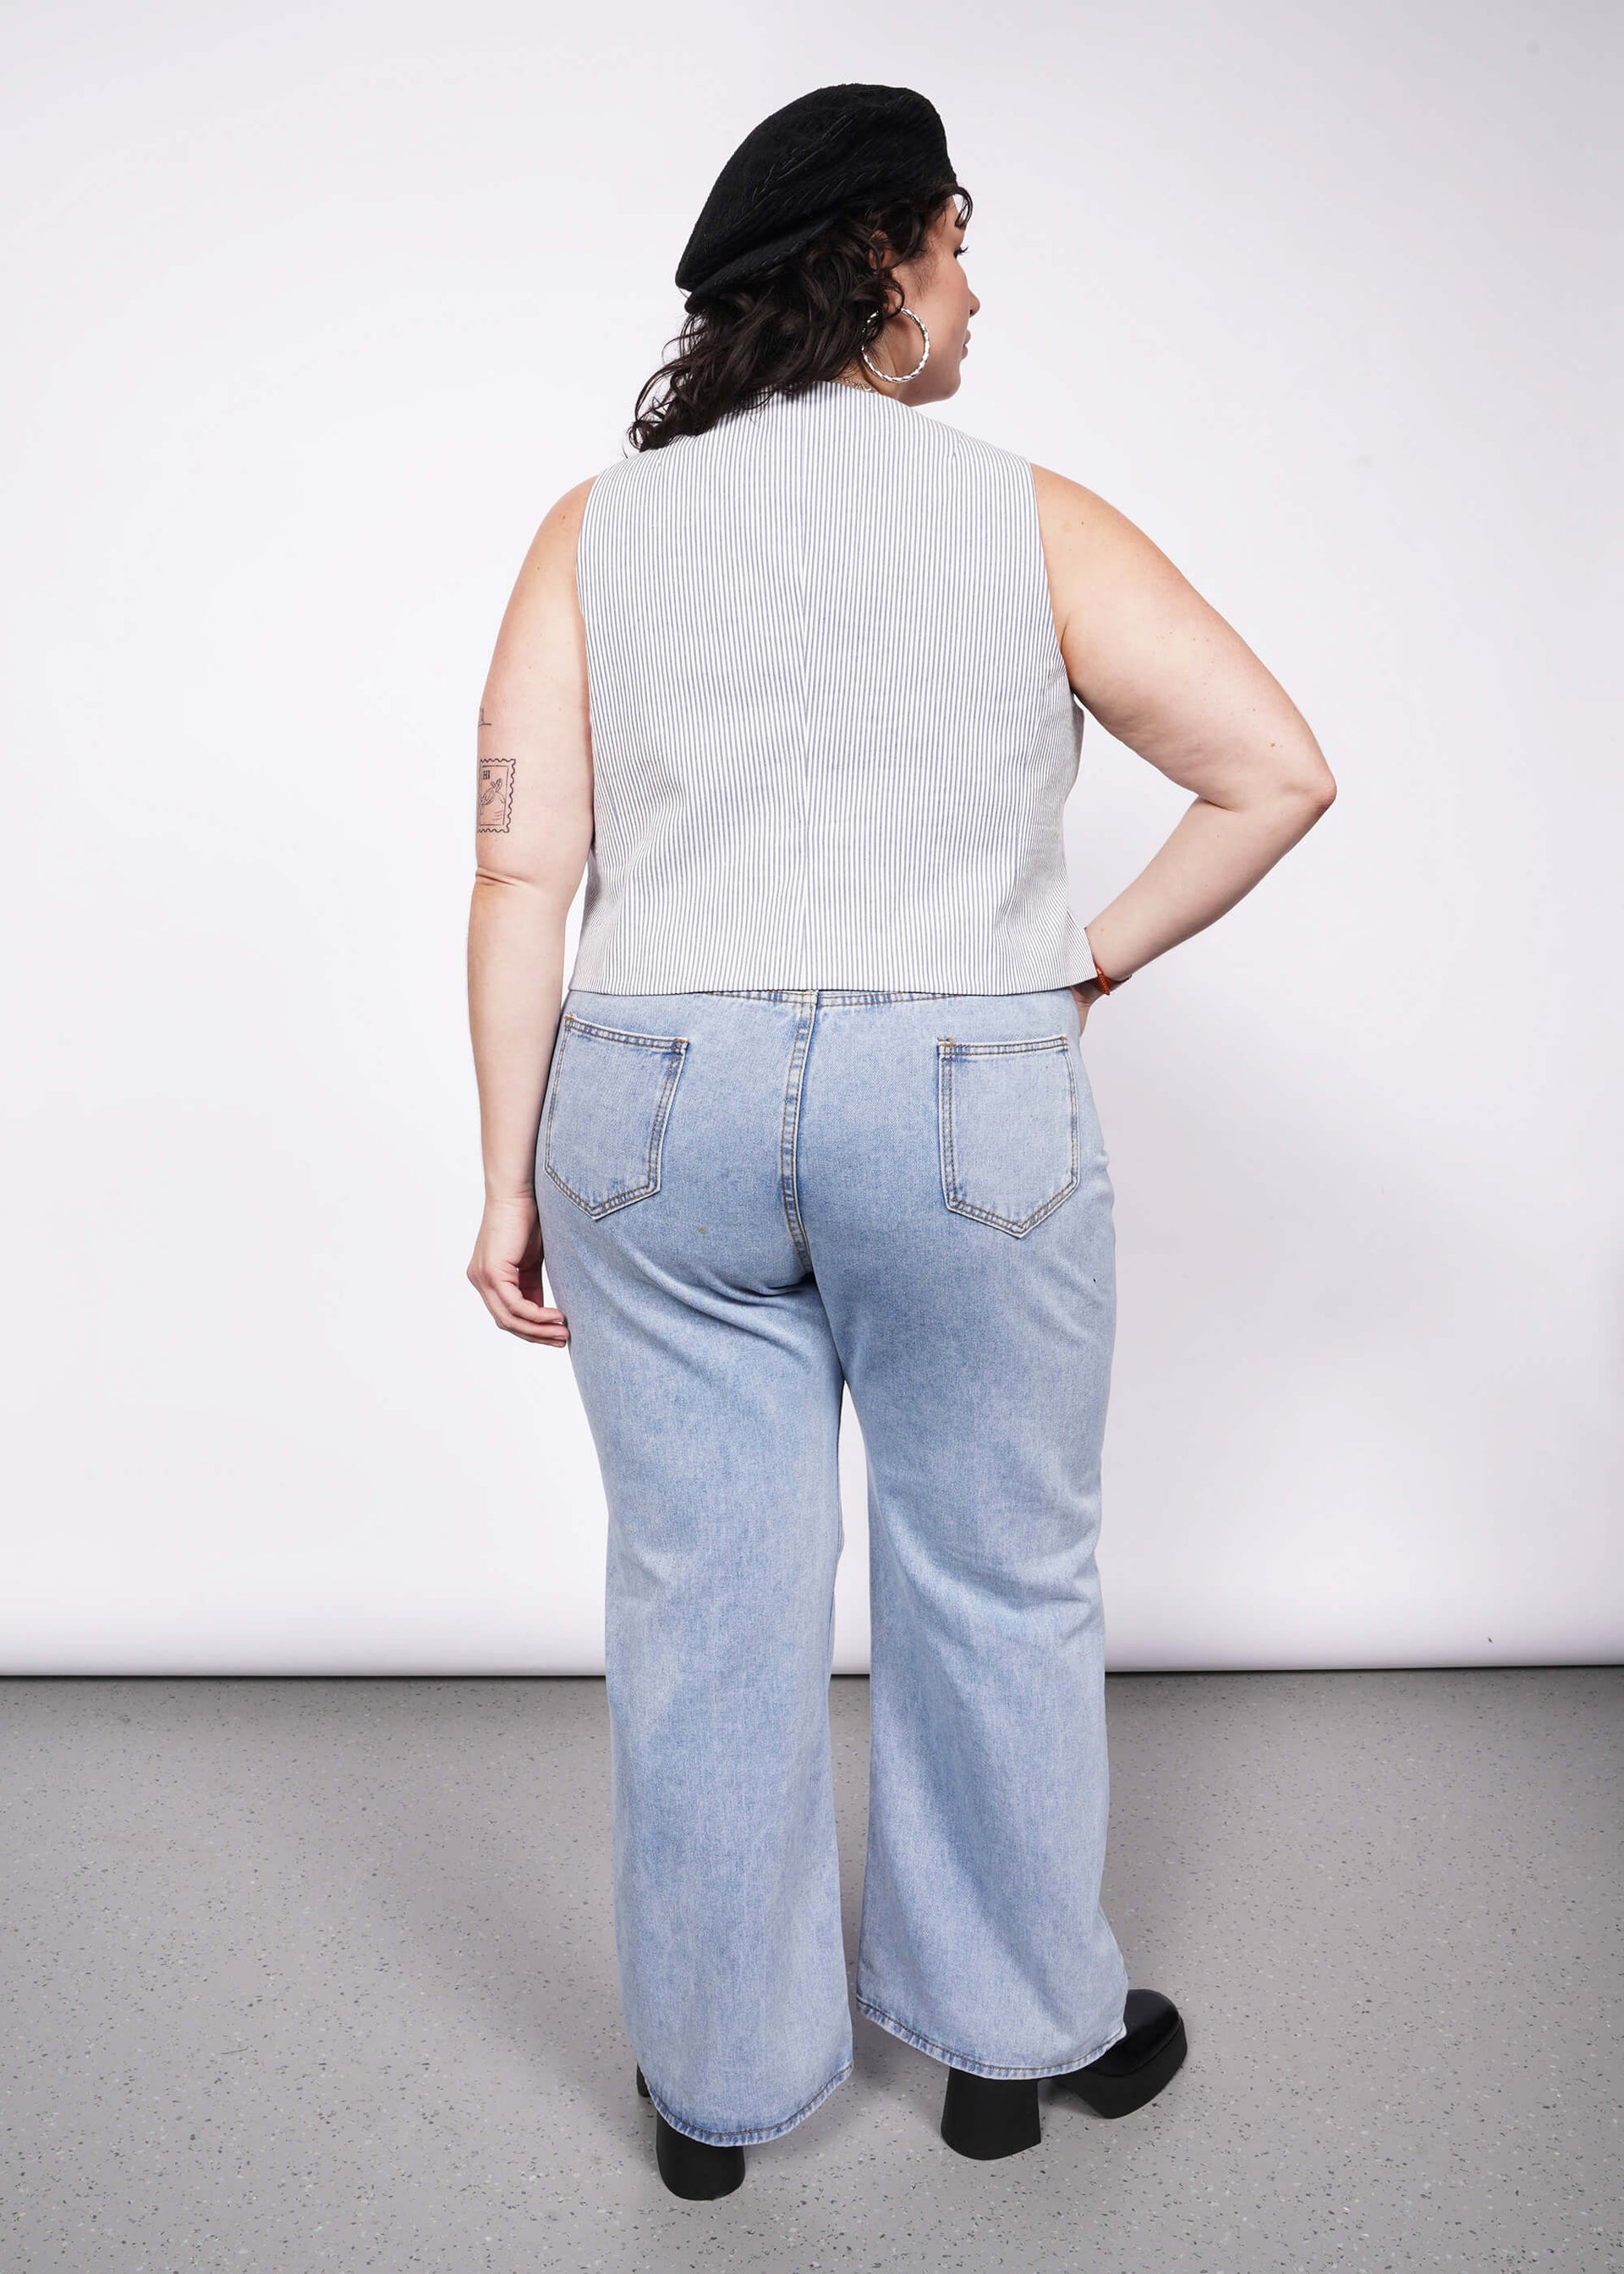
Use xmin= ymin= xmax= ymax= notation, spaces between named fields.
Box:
xmin=0 ymin=1669 xmax=1624 ymax=2274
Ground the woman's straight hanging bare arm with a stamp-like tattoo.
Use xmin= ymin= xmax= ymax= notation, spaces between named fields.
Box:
xmin=469 ymin=482 xmax=591 ymax=1344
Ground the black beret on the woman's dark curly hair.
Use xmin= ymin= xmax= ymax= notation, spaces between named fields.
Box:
xmin=676 ymin=84 xmax=953 ymax=310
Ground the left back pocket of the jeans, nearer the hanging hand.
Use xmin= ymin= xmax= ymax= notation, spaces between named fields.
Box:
xmin=541 ymin=1009 xmax=687 ymax=1217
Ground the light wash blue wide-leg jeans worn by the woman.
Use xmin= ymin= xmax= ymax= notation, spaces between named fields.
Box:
xmin=537 ymin=987 xmax=1128 ymax=2145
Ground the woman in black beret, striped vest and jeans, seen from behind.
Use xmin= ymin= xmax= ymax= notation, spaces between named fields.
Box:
xmin=469 ymin=86 xmax=1335 ymax=2197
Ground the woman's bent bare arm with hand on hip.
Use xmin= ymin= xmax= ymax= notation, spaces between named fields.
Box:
xmin=1033 ymin=466 xmax=1337 ymax=994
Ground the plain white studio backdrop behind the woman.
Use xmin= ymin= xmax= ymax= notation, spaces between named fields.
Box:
xmin=0 ymin=0 xmax=1624 ymax=1673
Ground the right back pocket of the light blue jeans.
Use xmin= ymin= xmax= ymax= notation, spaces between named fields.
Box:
xmin=937 ymin=1035 xmax=1078 ymax=1239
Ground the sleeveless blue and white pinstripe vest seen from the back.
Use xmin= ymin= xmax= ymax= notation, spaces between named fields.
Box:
xmin=571 ymin=380 xmax=1094 ymax=994
